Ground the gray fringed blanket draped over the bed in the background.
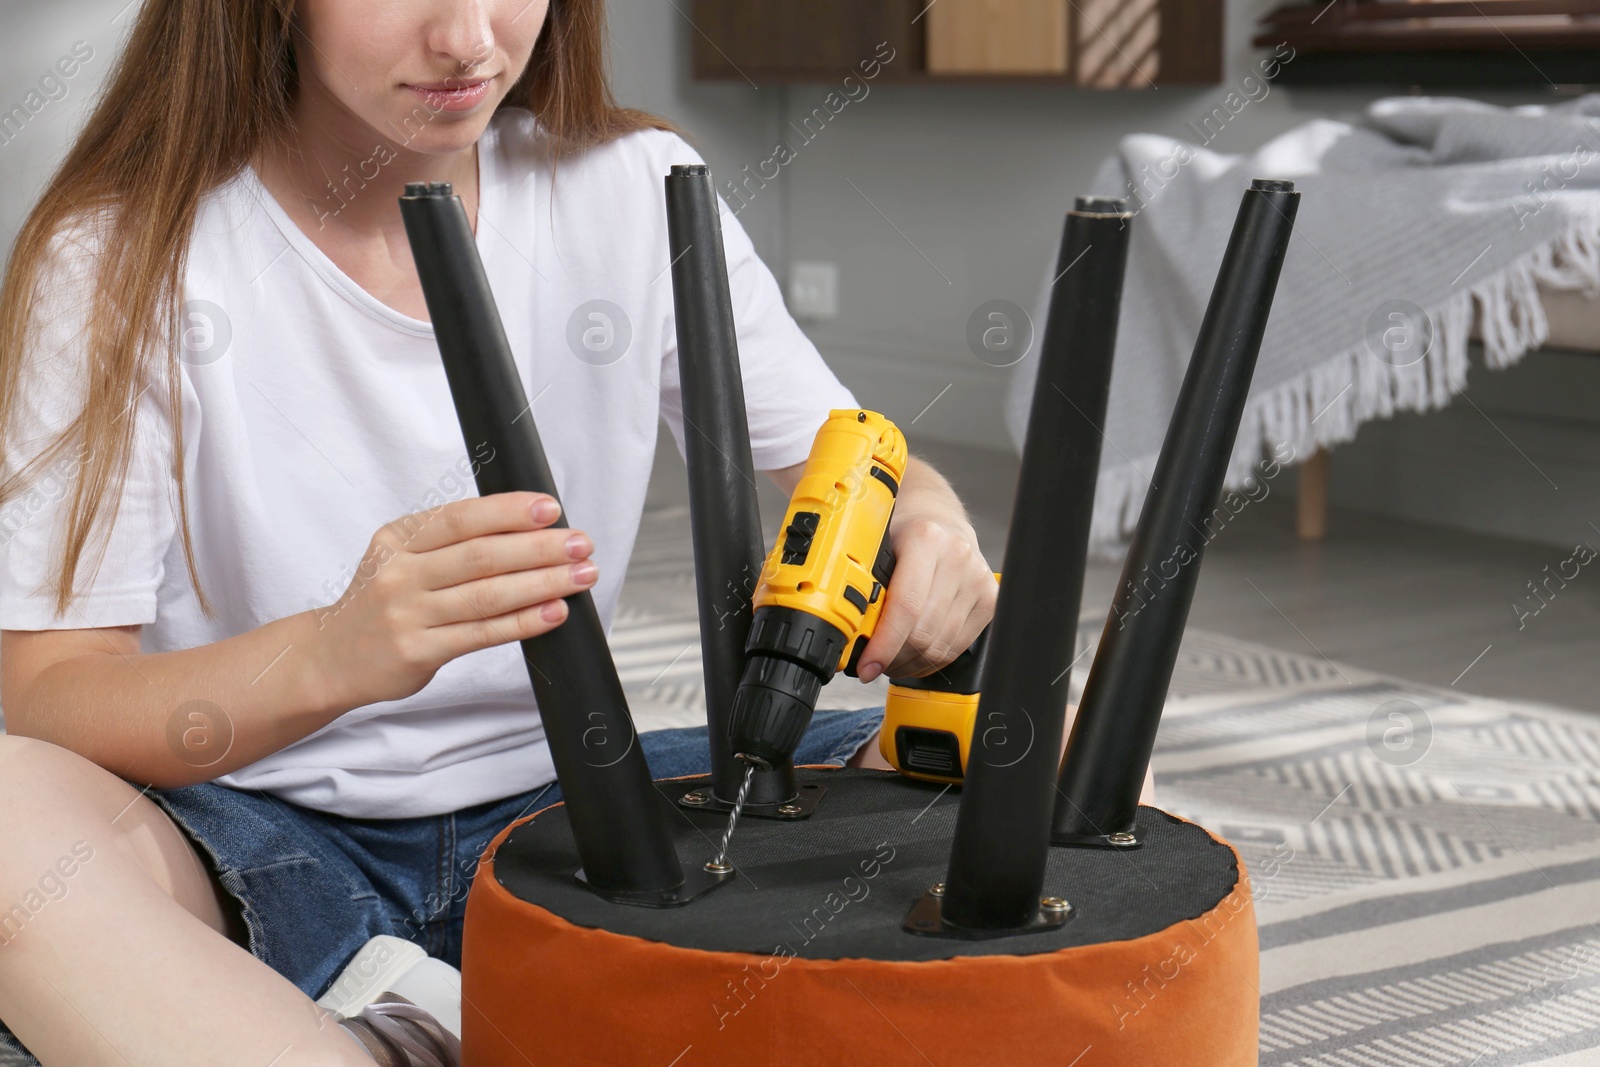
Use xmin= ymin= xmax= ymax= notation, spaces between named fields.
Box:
xmin=1006 ymin=94 xmax=1600 ymax=542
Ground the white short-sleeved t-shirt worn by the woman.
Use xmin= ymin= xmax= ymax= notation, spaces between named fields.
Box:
xmin=0 ymin=109 xmax=856 ymax=817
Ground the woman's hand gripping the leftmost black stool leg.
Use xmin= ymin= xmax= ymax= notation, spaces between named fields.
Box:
xmin=312 ymin=491 xmax=597 ymax=709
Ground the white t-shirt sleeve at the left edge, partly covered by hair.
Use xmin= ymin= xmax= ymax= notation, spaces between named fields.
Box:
xmin=0 ymin=220 xmax=176 ymax=630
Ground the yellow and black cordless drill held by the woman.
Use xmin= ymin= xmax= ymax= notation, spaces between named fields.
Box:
xmin=731 ymin=408 xmax=987 ymax=782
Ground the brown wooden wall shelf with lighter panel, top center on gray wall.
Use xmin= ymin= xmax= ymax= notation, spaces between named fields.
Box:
xmin=691 ymin=0 xmax=1224 ymax=88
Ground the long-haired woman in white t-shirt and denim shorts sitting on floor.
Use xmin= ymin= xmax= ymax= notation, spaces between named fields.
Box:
xmin=0 ymin=0 xmax=995 ymax=1067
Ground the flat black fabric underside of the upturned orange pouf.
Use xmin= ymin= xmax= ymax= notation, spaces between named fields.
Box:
xmin=494 ymin=768 xmax=1238 ymax=960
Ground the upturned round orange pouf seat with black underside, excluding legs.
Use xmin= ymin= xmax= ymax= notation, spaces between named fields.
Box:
xmin=462 ymin=769 xmax=1259 ymax=1067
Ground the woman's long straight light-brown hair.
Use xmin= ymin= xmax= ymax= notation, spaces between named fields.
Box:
xmin=0 ymin=0 xmax=675 ymax=616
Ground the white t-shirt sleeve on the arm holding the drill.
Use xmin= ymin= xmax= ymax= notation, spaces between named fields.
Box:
xmin=656 ymin=138 xmax=858 ymax=470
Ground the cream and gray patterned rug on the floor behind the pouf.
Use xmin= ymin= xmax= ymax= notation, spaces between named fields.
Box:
xmin=611 ymin=509 xmax=1600 ymax=1067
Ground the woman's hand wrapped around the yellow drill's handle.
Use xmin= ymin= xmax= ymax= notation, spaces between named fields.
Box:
xmin=856 ymin=508 xmax=1000 ymax=681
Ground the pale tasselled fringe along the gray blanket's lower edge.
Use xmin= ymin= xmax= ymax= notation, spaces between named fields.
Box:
xmin=1090 ymin=216 xmax=1600 ymax=553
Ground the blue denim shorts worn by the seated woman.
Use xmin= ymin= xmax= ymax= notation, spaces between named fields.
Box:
xmin=0 ymin=707 xmax=883 ymax=1067
